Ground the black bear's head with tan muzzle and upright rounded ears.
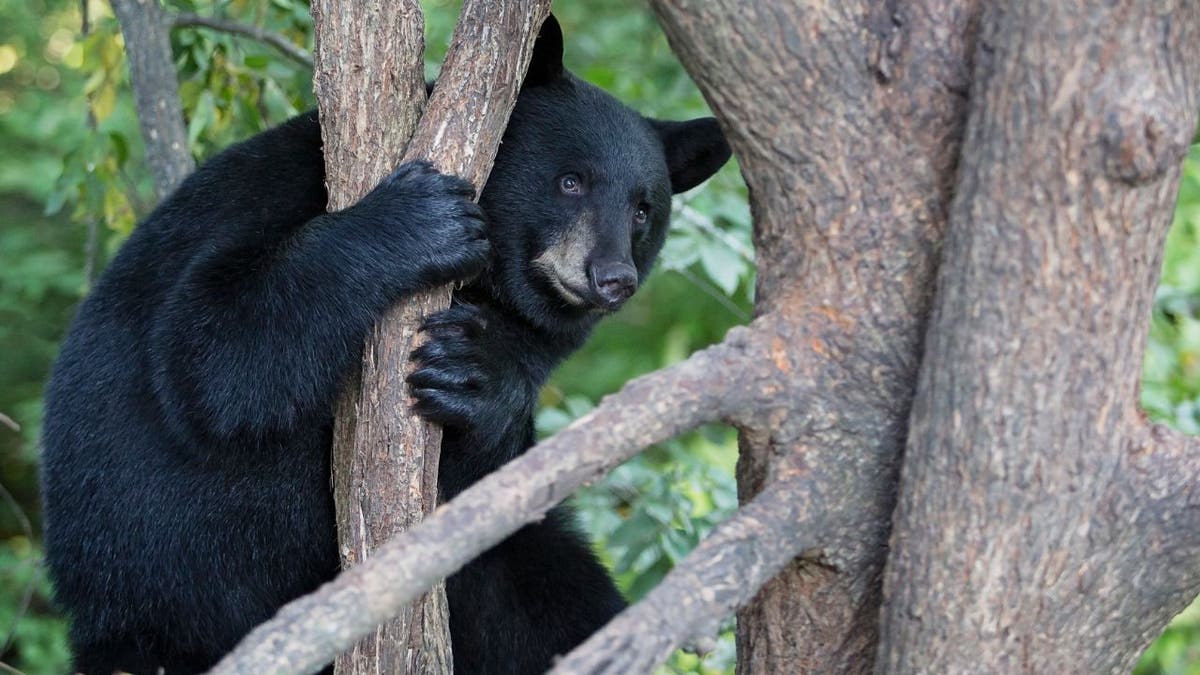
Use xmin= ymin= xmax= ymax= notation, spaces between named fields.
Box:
xmin=480 ymin=17 xmax=730 ymax=331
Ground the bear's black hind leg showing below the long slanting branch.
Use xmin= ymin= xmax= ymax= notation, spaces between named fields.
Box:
xmin=446 ymin=507 xmax=625 ymax=675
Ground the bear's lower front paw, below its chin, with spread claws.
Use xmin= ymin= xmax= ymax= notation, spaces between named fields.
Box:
xmin=408 ymin=305 xmax=532 ymax=435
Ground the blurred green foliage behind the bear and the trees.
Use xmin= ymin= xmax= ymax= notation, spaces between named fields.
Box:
xmin=0 ymin=0 xmax=1200 ymax=675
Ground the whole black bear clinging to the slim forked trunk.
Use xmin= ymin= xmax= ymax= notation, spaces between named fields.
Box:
xmin=43 ymin=19 xmax=730 ymax=675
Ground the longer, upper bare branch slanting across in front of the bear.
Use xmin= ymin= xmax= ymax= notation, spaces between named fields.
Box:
xmin=212 ymin=329 xmax=770 ymax=674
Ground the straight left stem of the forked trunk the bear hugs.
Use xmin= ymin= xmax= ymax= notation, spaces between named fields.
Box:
xmin=312 ymin=0 xmax=439 ymax=673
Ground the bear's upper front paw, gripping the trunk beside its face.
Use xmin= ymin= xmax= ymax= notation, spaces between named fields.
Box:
xmin=355 ymin=161 xmax=491 ymax=286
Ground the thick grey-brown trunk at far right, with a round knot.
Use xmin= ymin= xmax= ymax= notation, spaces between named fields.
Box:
xmin=880 ymin=0 xmax=1200 ymax=673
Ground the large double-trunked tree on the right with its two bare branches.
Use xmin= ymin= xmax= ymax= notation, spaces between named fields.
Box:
xmin=91 ymin=0 xmax=1200 ymax=673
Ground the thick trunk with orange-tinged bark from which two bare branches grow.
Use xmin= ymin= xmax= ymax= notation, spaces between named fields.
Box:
xmin=653 ymin=0 xmax=976 ymax=673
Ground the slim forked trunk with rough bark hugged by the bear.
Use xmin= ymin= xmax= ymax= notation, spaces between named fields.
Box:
xmin=313 ymin=0 xmax=550 ymax=673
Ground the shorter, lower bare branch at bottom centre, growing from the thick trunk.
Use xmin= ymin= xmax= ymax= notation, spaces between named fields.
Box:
xmin=551 ymin=477 xmax=824 ymax=675
